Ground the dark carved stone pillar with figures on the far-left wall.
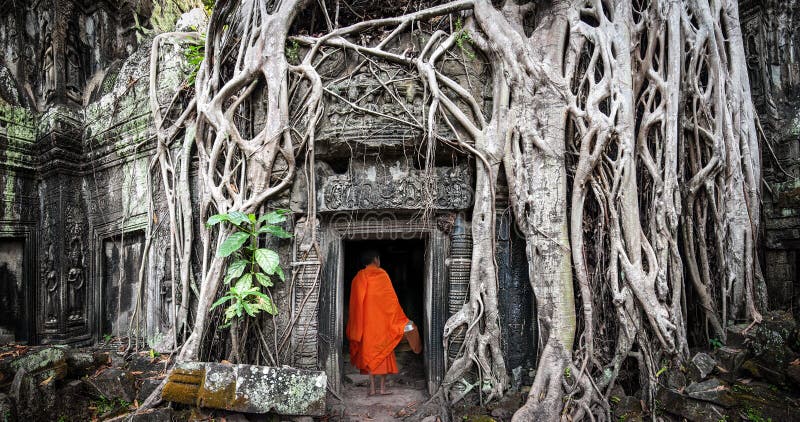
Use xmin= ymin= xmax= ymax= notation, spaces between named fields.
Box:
xmin=37 ymin=106 xmax=91 ymax=343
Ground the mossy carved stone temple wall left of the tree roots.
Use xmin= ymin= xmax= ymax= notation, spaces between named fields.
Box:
xmin=0 ymin=1 xmax=193 ymax=349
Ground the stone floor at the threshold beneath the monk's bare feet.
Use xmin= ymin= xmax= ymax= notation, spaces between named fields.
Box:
xmin=329 ymin=343 xmax=429 ymax=422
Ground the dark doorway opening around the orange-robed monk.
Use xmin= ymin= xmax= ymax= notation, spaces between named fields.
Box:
xmin=342 ymin=239 xmax=427 ymax=389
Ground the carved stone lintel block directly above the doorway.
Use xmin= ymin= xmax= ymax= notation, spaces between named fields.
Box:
xmin=320 ymin=166 xmax=472 ymax=211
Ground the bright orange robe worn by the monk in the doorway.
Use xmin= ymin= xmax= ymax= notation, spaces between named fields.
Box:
xmin=347 ymin=265 xmax=408 ymax=375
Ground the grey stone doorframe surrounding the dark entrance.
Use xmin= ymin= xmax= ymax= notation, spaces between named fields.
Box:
xmin=318 ymin=213 xmax=449 ymax=394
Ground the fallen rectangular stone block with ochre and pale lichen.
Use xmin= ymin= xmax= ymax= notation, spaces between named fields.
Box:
xmin=162 ymin=362 xmax=327 ymax=416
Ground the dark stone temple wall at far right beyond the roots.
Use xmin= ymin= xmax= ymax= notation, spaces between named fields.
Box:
xmin=739 ymin=0 xmax=800 ymax=317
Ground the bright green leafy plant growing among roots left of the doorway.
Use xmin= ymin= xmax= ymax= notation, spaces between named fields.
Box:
xmin=206 ymin=210 xmax=292 ymax=326
